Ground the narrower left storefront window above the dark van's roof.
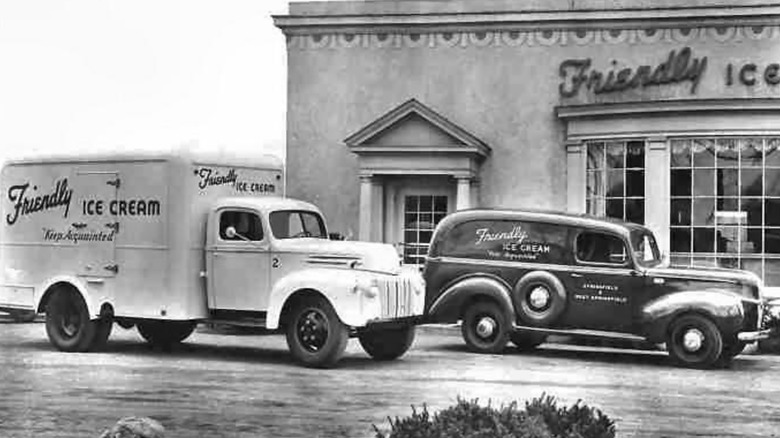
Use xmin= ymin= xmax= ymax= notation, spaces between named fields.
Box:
xmin=586 ymin=141 xmax=645 ymax=224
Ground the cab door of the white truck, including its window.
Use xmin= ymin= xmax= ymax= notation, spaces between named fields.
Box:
xmin=208 ymin=209 xmax=271 ymax=311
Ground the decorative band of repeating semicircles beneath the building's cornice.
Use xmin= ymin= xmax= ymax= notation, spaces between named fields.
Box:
xmin=286 ymin=25 xmax=780 ymax=50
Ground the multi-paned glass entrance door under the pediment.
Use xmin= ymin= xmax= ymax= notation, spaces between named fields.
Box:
xmin=403 ymin=195 xmax=447 ymax=266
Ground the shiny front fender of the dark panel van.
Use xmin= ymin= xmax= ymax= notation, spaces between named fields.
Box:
xmin=640 ymin=289 xmax=745 ymax=342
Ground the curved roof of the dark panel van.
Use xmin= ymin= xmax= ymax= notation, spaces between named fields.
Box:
xmin=439 ymin=208 xmax=648 ymax=235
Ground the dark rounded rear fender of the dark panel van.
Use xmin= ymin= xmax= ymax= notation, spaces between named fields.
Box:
xmin=428 ymin=274 xmax=515 ymax=322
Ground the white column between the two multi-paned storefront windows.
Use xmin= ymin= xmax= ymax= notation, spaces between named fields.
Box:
xmin=645 ymin=137 xmax=671 ymax=252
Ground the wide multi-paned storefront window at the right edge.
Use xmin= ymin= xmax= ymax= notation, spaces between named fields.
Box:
xmin=670 ymin=137 xmax=780 ymax=286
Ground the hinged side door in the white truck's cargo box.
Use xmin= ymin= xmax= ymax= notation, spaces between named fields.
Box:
xmin=68 ymin=171 xmax=121 ymax=277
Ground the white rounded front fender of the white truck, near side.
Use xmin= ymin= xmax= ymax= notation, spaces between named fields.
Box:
xmin=266 ymin=268 xmax=381 ymax=330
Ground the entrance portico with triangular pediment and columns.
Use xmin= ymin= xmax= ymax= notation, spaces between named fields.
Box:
xmin=344 ymin=99 xmax=490 ymax=261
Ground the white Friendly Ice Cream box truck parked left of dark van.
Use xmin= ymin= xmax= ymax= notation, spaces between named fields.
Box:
xmin=0 ymin=153 xmax=424 ymax=367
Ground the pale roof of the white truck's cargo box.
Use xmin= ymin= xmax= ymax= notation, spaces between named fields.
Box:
xmin=5 ymin=150 xmax=282 ymax=169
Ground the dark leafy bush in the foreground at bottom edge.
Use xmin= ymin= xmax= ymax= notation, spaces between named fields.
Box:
xmin=374 ymin=394 xmax=615 ymax=438
